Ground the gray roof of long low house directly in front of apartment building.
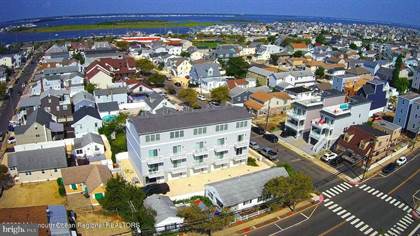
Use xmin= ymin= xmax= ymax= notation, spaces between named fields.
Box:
xmin=207 ymin=167 xmax=289 ymax=207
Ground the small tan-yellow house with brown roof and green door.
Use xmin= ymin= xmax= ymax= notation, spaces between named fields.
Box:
xmin=61 ymin=165 xmax=112 ymax=205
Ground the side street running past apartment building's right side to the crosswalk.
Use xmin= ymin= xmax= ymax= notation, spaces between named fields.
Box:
xmin=251 ymin=132 xmax=340 ymax=191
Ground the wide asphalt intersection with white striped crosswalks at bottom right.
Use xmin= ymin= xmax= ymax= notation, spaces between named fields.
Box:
xmin=248 ymin=150 xmax=420 ymax=236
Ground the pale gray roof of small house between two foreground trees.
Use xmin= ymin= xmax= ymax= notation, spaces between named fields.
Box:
xmin=144 ymin=194 xmax=177 ymax=223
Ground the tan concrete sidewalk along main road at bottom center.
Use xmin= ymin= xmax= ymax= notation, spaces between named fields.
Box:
xmin=213 ymin=201 xmax=317 ymax=236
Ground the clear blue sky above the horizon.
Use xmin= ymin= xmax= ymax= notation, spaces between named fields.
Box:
xmin=0 ymin=0 xmax=420 ymax=26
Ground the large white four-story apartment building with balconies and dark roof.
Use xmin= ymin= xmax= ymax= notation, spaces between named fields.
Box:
xmin=126 ymin=107 xmax=251 ymax=184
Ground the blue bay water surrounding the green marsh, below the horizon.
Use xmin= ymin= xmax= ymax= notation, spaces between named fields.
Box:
xmin=0 ymin=14 xmax=414 ymax=44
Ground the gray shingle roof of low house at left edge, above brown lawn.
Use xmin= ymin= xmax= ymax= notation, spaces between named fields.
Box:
xmin=8 ymin=147 xmax=67 ymax=172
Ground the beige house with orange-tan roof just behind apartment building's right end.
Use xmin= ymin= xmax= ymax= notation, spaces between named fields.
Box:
xmin=244 ymin=92 xmax=291 ymax=116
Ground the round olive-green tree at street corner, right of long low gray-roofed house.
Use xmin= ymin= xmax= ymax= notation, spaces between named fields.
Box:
xmin=263 ymin=172 xmax=314 ymax=210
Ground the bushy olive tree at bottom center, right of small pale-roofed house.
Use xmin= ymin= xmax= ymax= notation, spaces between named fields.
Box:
xmin=178 ymin=204 xmax=234 ymax=233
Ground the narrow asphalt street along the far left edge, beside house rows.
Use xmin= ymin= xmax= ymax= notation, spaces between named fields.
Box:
xmin=0 ymin=51 xmax=41 ymax=133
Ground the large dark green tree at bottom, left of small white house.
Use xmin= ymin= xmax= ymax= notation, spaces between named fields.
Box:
xmin=99 ymin=175 xmax=154 ymax=235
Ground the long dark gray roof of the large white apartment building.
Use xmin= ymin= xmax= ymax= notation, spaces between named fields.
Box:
xmin=129 ymin=106 xmax=251 ymax=135
